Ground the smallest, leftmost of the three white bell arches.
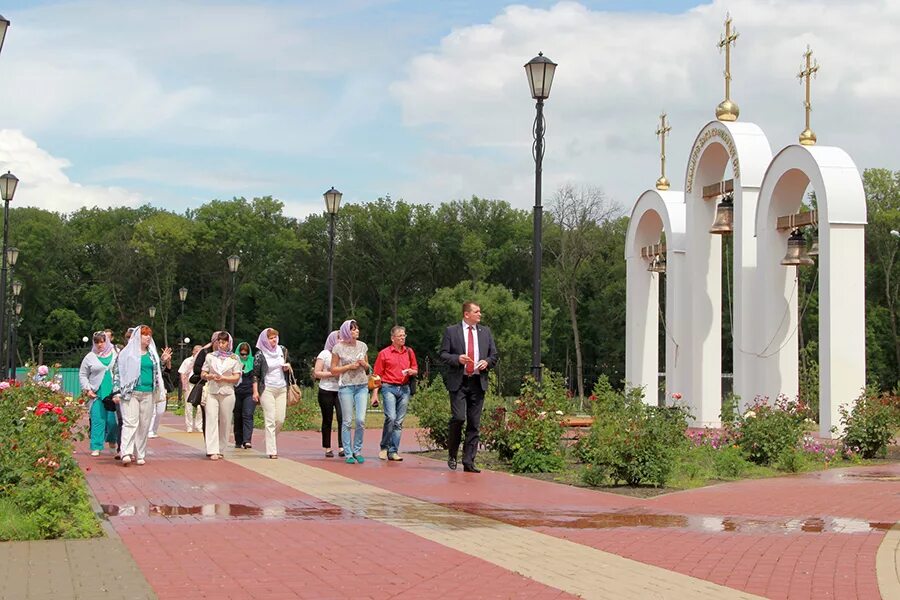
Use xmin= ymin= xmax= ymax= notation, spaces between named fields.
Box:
xmin=625 ymin=190 xmax=688 ymax=405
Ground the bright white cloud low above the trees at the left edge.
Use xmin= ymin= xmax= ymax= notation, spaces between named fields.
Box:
xmin=0 ymin=129 xmax=142 ymax=213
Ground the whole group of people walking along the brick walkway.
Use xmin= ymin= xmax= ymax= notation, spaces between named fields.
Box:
xmin=79 ymin=302 xmax=497 ymax=473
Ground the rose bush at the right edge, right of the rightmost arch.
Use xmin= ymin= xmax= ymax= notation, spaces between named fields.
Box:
xmin=841 ymin=389 xmax=900 ymax=458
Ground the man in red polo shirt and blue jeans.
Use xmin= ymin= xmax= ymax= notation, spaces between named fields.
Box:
xmin=374 ymin=325 xmax=419 ymax=461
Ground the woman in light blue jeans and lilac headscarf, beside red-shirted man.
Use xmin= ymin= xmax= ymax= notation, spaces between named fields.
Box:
xmin=331 ymin=319 xmax=369 ymax=464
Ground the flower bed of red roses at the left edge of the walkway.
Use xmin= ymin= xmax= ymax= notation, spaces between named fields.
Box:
xmin=0 ymin=367 xmax=100 ymax=540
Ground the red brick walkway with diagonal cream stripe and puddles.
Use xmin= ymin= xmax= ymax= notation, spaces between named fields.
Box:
xmin=67 ymin=417 xmax=900 ymax=599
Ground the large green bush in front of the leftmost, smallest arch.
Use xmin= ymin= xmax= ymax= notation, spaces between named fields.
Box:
xmin=576 ymin=377 xmax=689 ymax=487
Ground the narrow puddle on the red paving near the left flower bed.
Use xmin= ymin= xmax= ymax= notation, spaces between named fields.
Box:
xmin=100 ymin=504 xmax=355 ymax=521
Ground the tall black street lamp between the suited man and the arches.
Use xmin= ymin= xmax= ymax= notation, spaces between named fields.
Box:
xmin=525 ymin=52 xmax=556 ymax=382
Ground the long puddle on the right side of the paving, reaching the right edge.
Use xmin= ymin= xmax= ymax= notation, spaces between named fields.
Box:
xmin=448 ymin=505 xmax=893 ymax=534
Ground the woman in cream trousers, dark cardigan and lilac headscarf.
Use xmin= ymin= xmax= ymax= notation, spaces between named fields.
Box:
xmin=253 ymin=327 xmax=291 ymax=458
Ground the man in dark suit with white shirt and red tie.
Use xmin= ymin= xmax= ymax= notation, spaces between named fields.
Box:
xmin=441 ymin=302 xmax=498 ymax=473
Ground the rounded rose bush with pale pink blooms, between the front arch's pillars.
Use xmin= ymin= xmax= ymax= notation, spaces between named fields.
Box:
xmin=727 ymin=396 xmax=807 ymax=465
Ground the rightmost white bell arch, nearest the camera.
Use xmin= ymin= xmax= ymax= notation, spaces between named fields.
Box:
xmin=754 ymin=145 xmax=867 ymax=437
